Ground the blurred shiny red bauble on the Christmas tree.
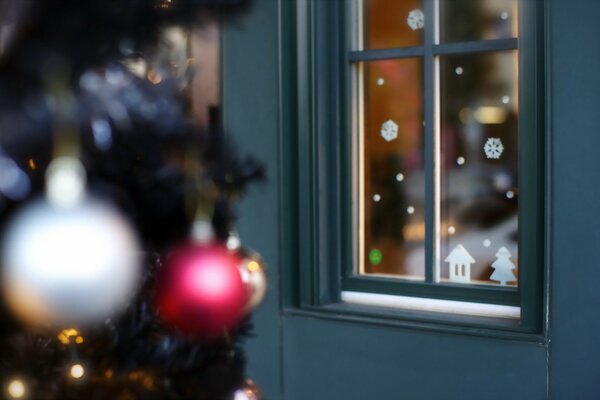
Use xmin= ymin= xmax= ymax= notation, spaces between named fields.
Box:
xmin=156 ymin=243 xmax=248 ymax=338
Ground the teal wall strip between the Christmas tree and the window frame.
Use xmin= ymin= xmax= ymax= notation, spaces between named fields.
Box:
xmin=223 ymin=0 xmax=281 ymax=400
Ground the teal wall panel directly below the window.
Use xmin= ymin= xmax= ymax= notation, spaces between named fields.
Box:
xmin=284 ymin=317 xmax=546 ymax=400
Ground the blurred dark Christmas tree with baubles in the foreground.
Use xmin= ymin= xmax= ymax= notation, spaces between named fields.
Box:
xmin=0 ymin=0 xmax=266 ymax=400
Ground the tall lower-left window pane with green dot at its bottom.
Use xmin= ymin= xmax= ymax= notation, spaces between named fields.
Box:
xmin=361 ymin=58 xmax=425 ymax=279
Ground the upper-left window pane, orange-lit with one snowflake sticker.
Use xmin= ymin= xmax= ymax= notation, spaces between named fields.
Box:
xmin=362 ymin=0 xmax=425 ymax=49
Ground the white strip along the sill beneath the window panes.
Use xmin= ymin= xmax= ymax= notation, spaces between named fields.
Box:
xmin=342 ymin=291 xmax=521 ymax=319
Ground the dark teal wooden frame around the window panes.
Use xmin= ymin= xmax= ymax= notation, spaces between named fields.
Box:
xmin=280 ymin=0 xmax=547 ymax=340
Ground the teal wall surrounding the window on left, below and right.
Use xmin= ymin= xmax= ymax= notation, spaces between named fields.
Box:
xmin=223 ymin=0 xmax=600 ymax=400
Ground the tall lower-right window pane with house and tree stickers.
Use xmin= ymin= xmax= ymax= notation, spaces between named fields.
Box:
xmin=440 ymin=51 xmax=519 ymax=286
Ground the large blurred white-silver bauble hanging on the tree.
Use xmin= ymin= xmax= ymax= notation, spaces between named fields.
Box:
xmin=1 ymin=158 xmax=139 ymax=326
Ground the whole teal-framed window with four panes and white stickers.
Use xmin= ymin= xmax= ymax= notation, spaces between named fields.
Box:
xmin=282 ymin=0 xmax=545 ymax=332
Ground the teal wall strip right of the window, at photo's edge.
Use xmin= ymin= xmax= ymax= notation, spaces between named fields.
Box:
xmin=549 ymin=0 xmax=600 ymax=400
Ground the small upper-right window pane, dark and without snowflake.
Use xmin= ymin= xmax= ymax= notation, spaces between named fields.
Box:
xmin=440 ymin=0 xmax=519 ymax=42
